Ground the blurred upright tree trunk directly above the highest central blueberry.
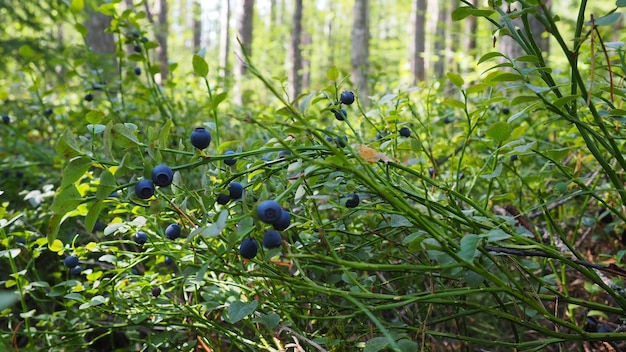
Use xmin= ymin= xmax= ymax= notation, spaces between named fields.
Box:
xmin=350 ymin=0 xmax=369 ymax=105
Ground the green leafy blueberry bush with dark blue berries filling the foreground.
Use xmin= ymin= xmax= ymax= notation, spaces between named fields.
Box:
xmin=0 ymin=0 xmax=626 ymax=352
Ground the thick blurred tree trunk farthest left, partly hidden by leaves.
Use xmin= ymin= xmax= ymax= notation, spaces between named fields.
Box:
xmin=85 ymin=8 xmax=117 ymax=76
